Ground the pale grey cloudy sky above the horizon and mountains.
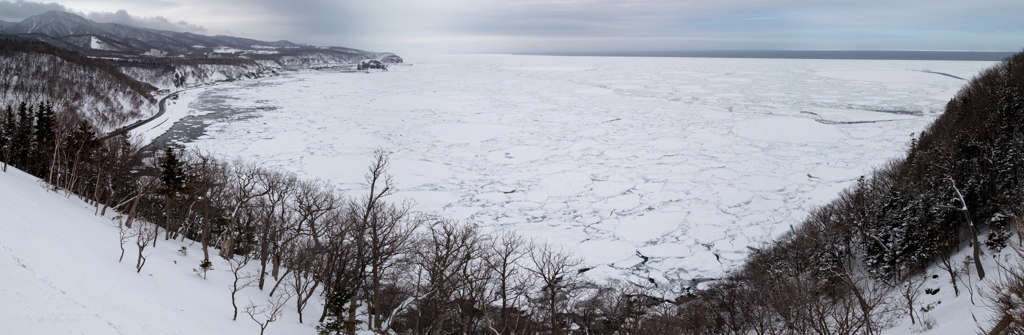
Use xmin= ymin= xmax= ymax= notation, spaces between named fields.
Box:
xmin=0 ymin=0 xmax=1024 ymax=54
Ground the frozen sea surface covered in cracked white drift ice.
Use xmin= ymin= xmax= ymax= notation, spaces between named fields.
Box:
xmin=174 ymin=55 xmax=993 ymax=288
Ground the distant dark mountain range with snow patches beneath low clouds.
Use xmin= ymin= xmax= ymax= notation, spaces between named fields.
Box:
xmin=0 ymin=10 xmax=401 ymax=67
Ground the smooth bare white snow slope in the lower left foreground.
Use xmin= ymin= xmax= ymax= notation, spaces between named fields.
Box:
xmin=0 ymin=168 xmax=321 ymax=335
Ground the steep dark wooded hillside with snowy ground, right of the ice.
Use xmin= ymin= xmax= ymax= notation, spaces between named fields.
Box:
xmin=667 ymin=53 xmax=1024 ymax=334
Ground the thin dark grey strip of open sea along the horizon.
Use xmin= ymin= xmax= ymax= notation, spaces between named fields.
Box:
xmin=520 ymin=50 xmax=1015 ymax=60
